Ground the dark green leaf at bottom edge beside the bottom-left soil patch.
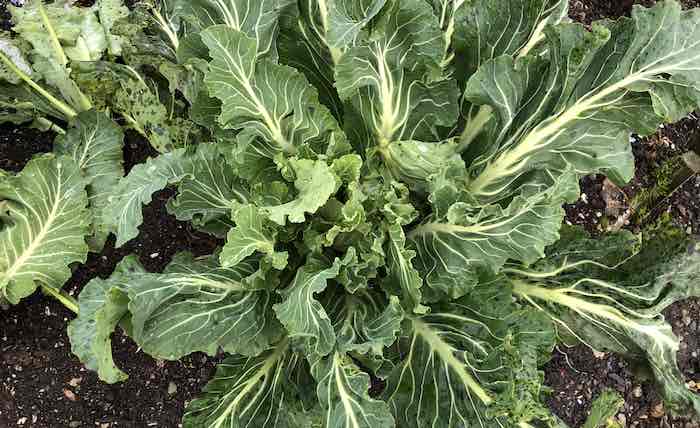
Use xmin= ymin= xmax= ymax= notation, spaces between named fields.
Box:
xmin=183 ymin=340 xmax=322 ymax=428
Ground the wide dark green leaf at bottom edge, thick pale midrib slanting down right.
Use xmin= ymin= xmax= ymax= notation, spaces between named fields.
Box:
xmin=385 ymin=306 xmax=554 ymax=428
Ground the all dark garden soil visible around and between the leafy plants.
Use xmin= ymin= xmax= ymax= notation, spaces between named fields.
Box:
xmin=0 ymin=0 xmax=700 ymax=428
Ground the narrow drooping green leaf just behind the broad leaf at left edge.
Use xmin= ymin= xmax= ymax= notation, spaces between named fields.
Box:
xmin=54 ymin=110 xmax=124 ymax=251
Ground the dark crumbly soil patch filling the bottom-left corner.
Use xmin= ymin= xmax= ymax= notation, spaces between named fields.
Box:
xmin=0 ymin=295 xmax=221 ymax=428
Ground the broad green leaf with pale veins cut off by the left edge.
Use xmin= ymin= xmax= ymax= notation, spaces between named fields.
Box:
xmin=0 ymin=155 xmax=91 ymax=304
